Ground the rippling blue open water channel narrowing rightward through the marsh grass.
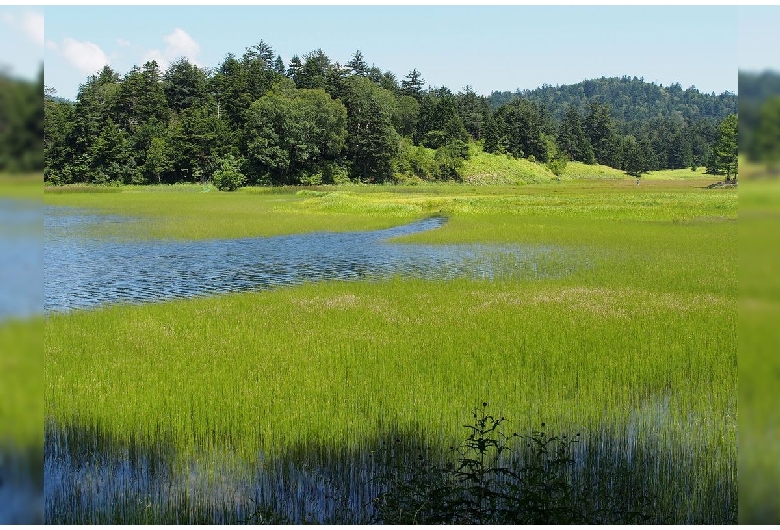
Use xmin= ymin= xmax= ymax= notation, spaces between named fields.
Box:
xmin=44 ymin=207 xmax=573 ymax=313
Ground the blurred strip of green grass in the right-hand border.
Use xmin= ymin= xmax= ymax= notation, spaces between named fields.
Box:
xmin=739 ymin=161 xmax=780 ymax=524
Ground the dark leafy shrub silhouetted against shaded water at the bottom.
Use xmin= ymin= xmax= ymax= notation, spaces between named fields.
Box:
xmin=374 ymin=403 xmax=652 ymax=525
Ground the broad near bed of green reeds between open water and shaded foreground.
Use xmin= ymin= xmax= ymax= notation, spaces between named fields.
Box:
xmin=46 ymin=272 xmax=734 ymax=450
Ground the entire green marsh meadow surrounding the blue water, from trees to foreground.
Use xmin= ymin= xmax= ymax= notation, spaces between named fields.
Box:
xmin=44 ymin=172 xmax=737 ymax=523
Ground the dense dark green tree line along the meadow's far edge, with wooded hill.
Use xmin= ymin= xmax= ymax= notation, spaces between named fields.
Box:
xmin=44 ymin=41 xmax=736 ymax=189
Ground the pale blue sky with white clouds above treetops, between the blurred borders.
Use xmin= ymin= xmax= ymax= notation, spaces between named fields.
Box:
xmin=32 ymin=5 xmax=739 ymax=98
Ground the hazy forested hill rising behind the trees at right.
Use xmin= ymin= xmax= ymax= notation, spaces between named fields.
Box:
xmin=488 ymin=76 xmax=742 ymax=129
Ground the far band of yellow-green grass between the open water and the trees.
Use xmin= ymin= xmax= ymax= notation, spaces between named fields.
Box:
xmin=44 ymin=176 xmax=735 ymax=240
